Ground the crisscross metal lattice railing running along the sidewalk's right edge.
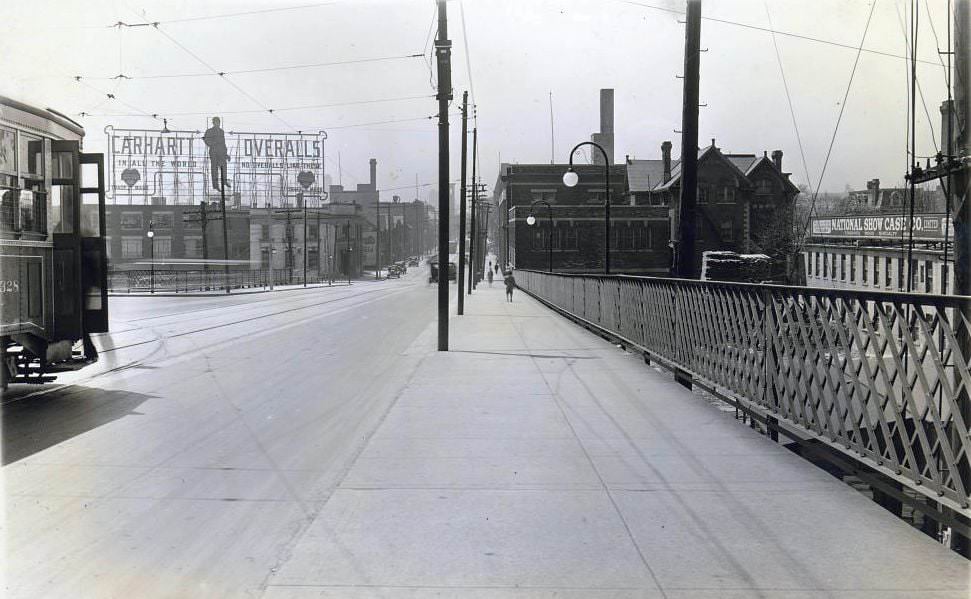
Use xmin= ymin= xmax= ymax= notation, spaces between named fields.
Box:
xmin=516 ymin=271 xmax=971 ymax=515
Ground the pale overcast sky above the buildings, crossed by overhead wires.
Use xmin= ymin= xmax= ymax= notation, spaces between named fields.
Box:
xmin=0 ymin=0 xmax=947 ymax=199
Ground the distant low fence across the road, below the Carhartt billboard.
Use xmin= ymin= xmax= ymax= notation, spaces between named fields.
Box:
xmin=108 ymin=268 xmax=338 ymax=293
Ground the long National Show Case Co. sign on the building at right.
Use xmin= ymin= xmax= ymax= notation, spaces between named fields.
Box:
xmin=810 ymin=214 xmax=954 ymax=241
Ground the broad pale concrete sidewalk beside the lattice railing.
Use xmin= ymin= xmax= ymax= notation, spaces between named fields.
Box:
xmin=265 ymin=284 xmax=971 ymax=599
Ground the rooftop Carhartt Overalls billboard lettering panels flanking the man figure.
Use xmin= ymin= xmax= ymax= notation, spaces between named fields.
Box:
xmin=105 ymin=125 xmax=327 ymax=207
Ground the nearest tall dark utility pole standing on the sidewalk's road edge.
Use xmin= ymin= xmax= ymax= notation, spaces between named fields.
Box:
xmin=435 ymin=0 xmax=452 ymax=351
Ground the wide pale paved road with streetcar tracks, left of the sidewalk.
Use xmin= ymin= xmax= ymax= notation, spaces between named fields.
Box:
xmin=2 ymin=269 xmax=435 ymax=598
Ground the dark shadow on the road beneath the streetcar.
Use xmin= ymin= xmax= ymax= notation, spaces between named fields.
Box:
xmin=0 ymin=385 xmax=152 ymax=466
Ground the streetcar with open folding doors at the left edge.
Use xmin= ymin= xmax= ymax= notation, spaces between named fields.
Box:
xmin=0 ymin=96 xmax=108 ymax=388
